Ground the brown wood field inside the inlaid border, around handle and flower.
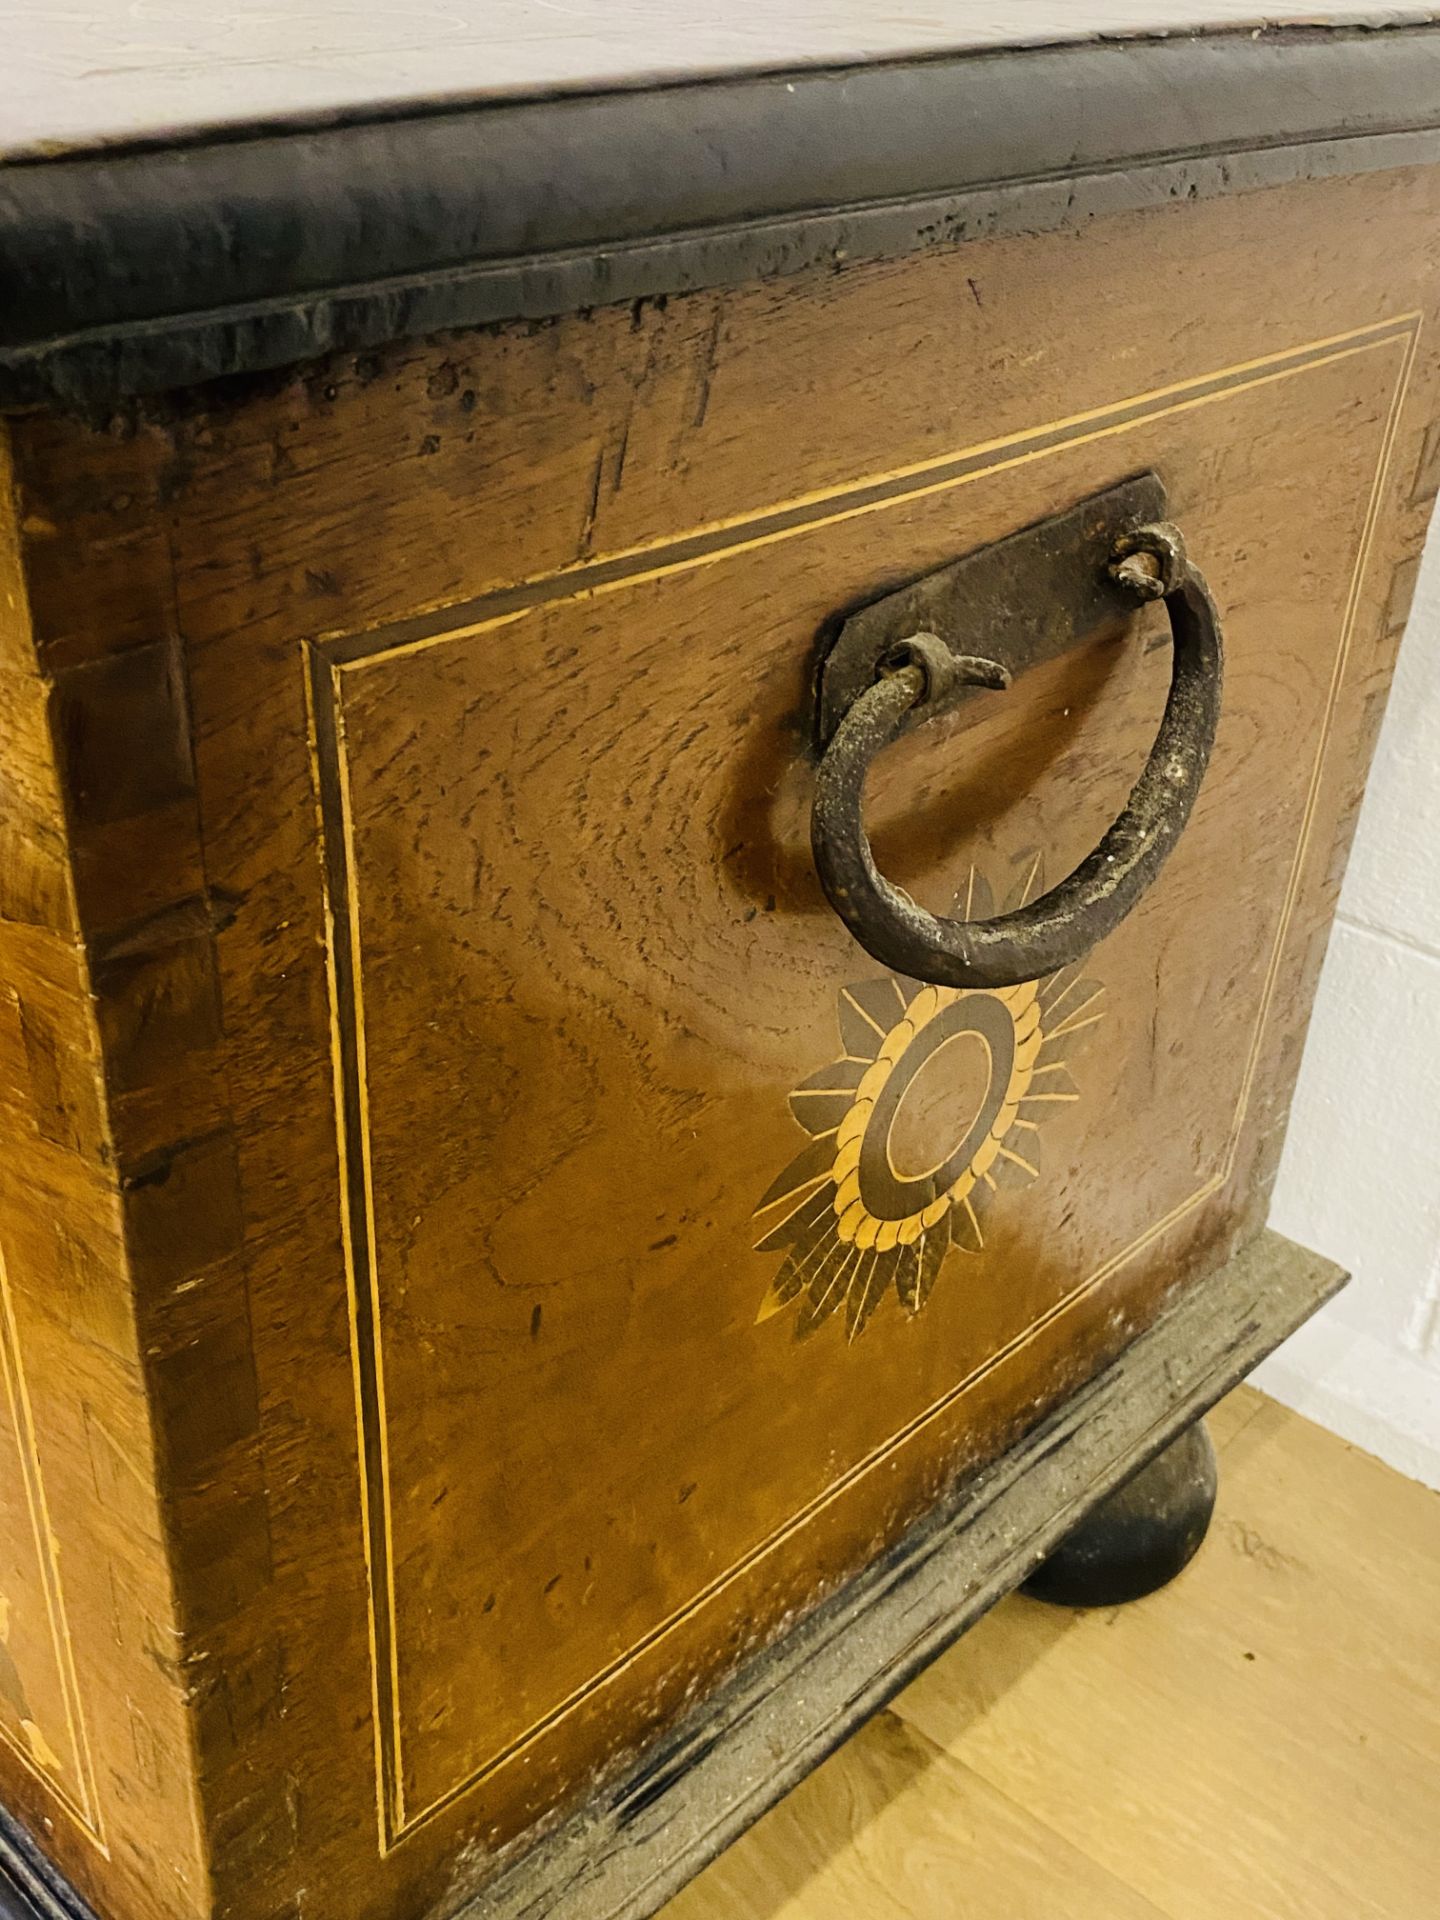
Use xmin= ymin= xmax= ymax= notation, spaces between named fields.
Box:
xmin=323 ymin=332 xmax=1409 ymax=1836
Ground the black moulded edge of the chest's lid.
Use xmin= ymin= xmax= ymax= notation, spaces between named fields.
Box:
xmin=0 ymin=25 xmax=1440 ymax=407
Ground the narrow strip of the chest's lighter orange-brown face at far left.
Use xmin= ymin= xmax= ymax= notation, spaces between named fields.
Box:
xmin=0 ymin=444 xmax=204 ymax=1914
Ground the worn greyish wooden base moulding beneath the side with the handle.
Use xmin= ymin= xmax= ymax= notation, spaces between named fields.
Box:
xmin=480 ymin=1233 xmax=1344 ymax=1920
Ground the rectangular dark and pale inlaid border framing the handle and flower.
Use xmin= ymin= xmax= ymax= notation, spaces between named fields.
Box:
xmin=303 ymin=313 xmax=1421 ymax=1855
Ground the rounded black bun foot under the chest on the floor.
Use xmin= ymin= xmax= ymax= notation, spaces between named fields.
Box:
xmin=1025 ymin=1421 xmax=1215 ymax=1607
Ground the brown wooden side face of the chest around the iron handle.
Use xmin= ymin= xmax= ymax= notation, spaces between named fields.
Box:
xmin=0 ymin=161 xmax=1440 ymax=1920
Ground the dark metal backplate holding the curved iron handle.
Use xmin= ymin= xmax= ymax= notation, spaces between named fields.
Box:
xmin=816 ymin=472 xmax=1165 ymax=747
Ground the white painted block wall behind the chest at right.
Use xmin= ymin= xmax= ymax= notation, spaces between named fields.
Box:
xmin=1256 ymin=510 xmax=1440 ymax=1488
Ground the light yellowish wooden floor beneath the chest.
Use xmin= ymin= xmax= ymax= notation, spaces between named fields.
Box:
xmin=664 ymin=1388 xmax=1440 ymax=1920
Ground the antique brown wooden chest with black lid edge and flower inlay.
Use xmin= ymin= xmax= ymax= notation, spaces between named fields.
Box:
xmin=0 ymin=11 xmax=1440 ymax=1920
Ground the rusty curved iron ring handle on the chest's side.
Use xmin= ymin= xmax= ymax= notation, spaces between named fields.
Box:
xmin=810 ymin=522 xmax=1223 ymax=987
